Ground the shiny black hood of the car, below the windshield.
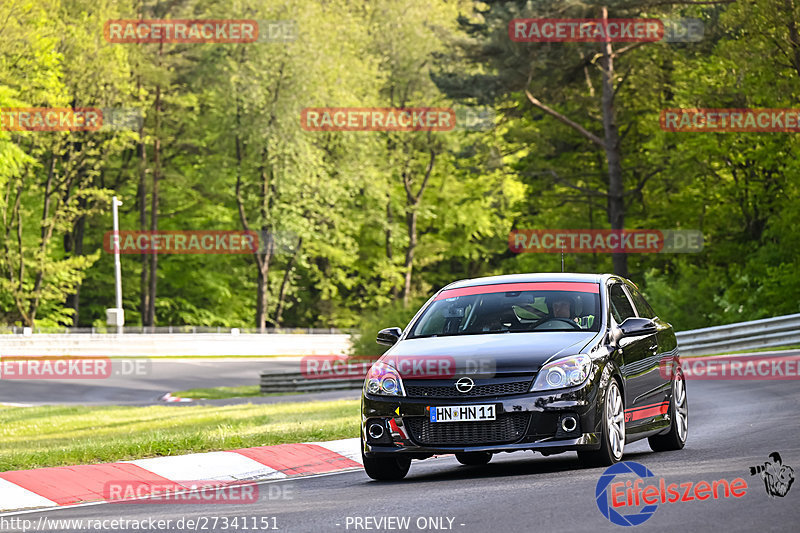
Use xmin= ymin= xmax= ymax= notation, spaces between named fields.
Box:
xmin=380 ymin=331 xmax=598 ymax=377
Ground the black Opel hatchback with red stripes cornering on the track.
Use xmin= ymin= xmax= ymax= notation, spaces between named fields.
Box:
xmin=361 ymin=274 xmax=688 ymax=480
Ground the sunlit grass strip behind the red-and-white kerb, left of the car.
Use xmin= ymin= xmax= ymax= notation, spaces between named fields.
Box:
xmin=0 ymin=400 xmax=359 ymax=471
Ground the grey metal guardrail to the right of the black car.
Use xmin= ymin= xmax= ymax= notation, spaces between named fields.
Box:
xmin=675 ymin=313 xmax=800 ymax=355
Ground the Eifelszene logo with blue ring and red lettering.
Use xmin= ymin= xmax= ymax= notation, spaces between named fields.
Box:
xmin=595 ymin=461 xmax=748 ymax=526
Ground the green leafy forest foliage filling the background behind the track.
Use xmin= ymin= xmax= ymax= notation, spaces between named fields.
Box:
xmin=0 ymin=0 xmax=800 ymax=332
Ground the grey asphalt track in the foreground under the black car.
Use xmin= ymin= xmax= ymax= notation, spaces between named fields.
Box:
xmin=0 ymin=381 xmax=800 ymax=533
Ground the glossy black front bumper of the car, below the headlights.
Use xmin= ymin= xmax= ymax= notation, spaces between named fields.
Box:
xmin=361 ymin=369 xmax=602 ymax=458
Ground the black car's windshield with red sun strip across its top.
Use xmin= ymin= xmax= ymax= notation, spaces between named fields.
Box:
xmin=407 ymin=283 xmax=600 ymax=339
